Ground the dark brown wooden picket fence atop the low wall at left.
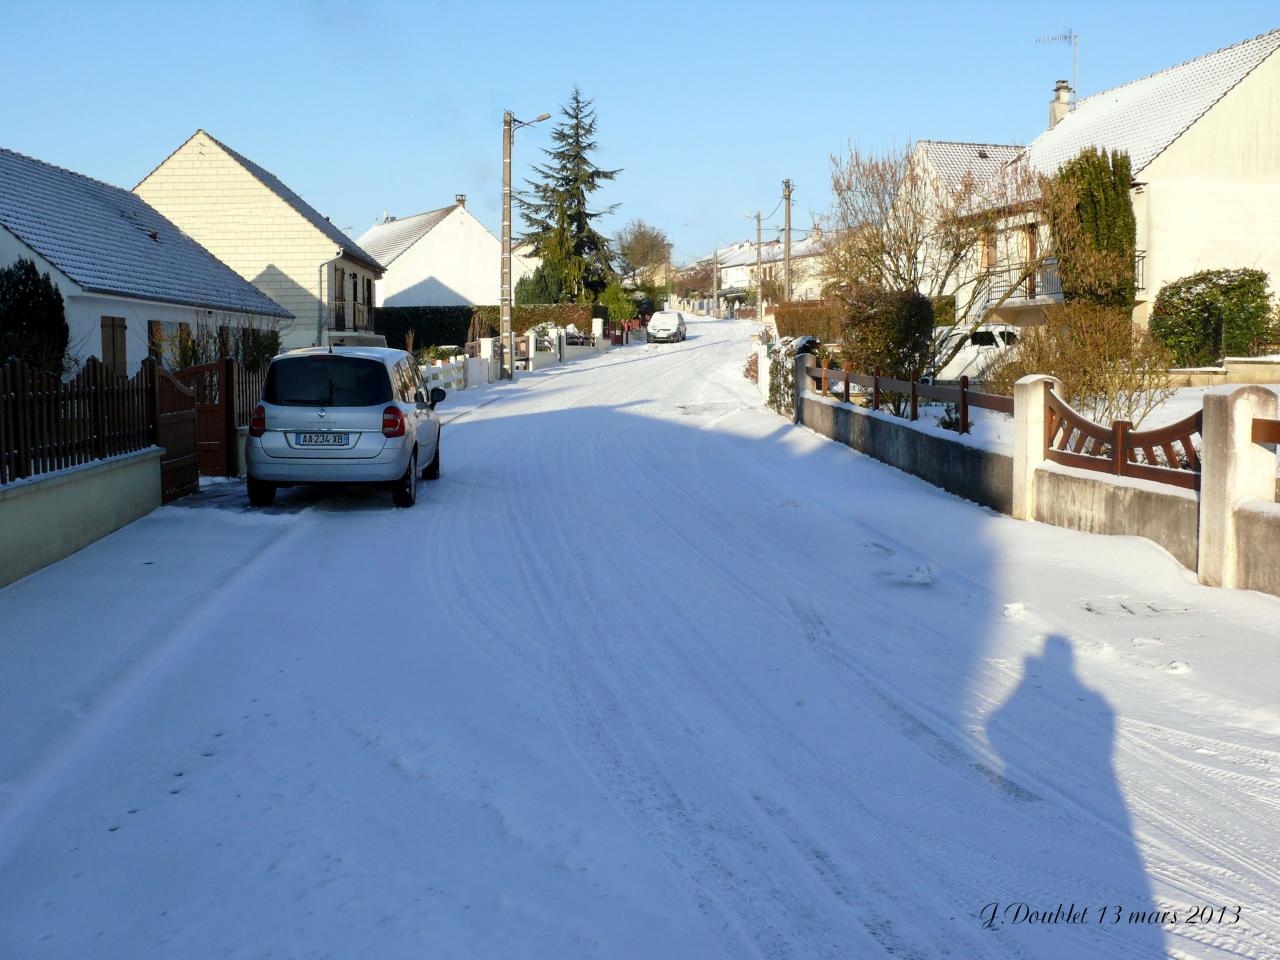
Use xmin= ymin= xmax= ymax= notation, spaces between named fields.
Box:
xmin=0 ymin=357 xmax=156 ymax=484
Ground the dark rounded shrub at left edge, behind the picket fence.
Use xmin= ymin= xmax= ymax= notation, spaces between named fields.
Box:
xmin=0 ymin=260 xmax=70 ymax=375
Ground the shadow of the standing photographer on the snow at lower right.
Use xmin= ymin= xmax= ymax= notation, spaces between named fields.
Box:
xmin=987 ymin=635 xmax=1166 ymax=960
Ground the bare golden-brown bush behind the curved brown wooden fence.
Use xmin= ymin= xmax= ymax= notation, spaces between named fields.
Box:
xmin=984 ymin=301 xmax=1172 ymax=426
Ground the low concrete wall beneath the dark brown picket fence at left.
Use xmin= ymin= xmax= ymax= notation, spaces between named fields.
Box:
xmin=0 ymin=447 xmax=164 ymax=586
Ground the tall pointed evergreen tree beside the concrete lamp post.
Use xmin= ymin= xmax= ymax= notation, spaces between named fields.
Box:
xmin=516 ymin=87 xmax=621 ymax=302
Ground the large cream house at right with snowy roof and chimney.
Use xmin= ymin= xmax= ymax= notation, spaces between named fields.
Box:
xmin=977 ymin=29 xmax=1280 ymax=324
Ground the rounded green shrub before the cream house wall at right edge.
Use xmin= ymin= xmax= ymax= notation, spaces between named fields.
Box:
xmin=1151 ymin=270 xmax=1275 ymax=366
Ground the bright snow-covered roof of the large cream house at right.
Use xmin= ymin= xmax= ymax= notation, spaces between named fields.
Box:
xmin=1028 ymin=29 xmax=1280 ymax=174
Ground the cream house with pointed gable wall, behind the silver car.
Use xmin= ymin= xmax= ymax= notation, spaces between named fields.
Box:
xmin=133 ymin=131 xmax=383 ymax=347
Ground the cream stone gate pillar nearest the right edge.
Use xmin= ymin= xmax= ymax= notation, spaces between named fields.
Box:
xmin=1197 ymin=387 xmax=1277 ymax=586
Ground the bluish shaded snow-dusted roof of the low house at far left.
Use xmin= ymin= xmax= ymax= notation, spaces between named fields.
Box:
xmin=0 ymin=147 xmax=293 ymax=319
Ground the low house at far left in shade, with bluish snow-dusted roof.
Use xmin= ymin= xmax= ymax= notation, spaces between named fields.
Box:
xmin=0 ymin=148 xmax=293 ymax=374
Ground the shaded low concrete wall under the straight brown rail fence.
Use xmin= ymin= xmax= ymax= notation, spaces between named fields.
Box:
xmin=796 ymin=393 xmax=1014 ymax=513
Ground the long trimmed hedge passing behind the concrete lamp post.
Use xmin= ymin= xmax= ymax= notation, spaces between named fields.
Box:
xmin=374 ymin=303 xmax=608 ymax=348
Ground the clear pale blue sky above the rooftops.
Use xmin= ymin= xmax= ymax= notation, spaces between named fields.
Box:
xmin=0 ymin=0 xmax=1280 ymax=260
